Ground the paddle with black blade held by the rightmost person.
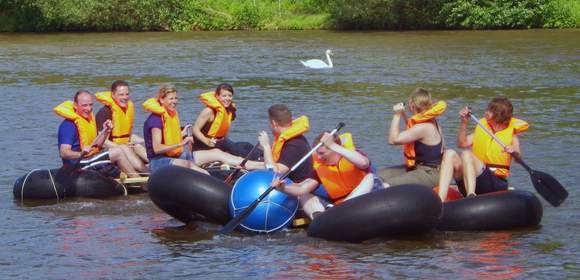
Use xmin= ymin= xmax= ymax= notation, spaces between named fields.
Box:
xmin=471 ymin=114 xmax=568 ymax=207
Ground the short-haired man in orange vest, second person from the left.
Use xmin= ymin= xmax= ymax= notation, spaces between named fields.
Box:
xmin=95 ymin=81 xmax=148 ymax=173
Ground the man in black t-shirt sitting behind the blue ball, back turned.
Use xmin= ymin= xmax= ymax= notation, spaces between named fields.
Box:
xmin=258 ymin=104 xmax=312 ymax=182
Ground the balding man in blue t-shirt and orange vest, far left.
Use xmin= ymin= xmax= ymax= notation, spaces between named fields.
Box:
xmin=54 ymin=90 xmax=141 ymax=177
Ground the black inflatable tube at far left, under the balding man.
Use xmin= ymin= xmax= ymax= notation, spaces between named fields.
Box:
xmin=13 ymin=166 xmax=127 ymax=201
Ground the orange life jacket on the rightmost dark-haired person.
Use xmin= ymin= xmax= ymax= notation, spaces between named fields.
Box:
xmin=471 ymin=118 xmax=529 ymax=179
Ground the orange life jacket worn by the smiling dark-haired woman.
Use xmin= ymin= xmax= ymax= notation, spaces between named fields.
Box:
xmin=199 ymin=91 xmax=236 ymax=138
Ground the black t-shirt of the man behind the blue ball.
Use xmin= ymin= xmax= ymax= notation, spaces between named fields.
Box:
xmin=278 ymin=135 xmax=314 ymax=183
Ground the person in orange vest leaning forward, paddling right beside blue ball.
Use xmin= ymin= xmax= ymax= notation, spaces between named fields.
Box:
xmin=273 ymin=132 xmax=385 ymax=219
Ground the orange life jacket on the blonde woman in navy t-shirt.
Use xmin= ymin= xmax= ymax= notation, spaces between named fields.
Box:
xmin=143 ymin=98 xmax=183 ymax=157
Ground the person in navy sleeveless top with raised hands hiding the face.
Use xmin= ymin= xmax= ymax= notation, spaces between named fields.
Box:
xmin=378 ymin=88 xmax=447 ymax=188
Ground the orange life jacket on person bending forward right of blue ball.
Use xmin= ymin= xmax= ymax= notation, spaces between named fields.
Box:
xmin=312 ymin=133 xmax=368 ymax=202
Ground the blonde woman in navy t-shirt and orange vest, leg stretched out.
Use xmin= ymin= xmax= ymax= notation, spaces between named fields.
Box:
xmin=143 ymin=84 xmax=264 ymax=174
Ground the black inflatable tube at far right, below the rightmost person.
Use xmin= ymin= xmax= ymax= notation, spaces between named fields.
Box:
xmin=437 ymin=190 xmax=543 ymax=231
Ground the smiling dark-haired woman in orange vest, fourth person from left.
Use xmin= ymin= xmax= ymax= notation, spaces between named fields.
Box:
xmin=193 ymin=83 xmax=252 ymax=156
